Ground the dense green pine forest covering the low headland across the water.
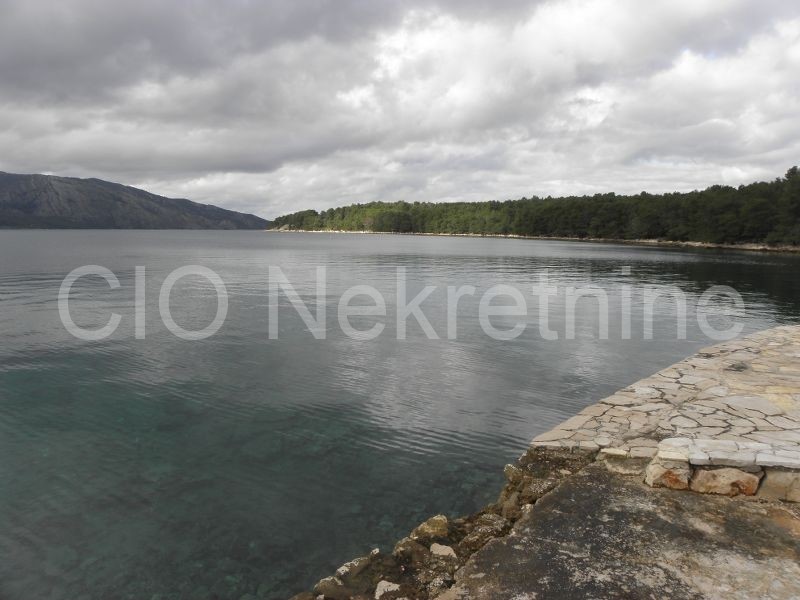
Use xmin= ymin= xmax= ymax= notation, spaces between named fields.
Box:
xmin=273 ymin=167 xmax=800 ymax=245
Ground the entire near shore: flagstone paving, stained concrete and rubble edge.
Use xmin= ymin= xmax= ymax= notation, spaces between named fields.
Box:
xmin=292 ymin=327 xmax=800 ymax=600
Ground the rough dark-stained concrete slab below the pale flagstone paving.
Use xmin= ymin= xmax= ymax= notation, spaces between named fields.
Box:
xmin=440 ymin=463 xmax=800 ymax=600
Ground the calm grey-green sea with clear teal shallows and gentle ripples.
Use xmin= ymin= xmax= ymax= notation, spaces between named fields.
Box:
xmin=0 ymin=231 xmax=800 ymax=600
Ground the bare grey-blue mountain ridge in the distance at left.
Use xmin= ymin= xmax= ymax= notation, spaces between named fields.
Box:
xmin=0 ymin=171 xmax=270 ymax=229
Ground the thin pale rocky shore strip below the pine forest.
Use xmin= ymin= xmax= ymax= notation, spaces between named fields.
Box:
xmin=263 ymin=229 xmax=800 ymax=254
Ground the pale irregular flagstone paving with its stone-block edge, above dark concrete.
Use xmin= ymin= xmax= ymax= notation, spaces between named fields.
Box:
xmin=533 ymin=326 xmax=800 ymax=502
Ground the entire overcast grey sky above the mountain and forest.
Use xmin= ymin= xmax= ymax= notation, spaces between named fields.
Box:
xmin=0 ymin=0 xmax=800 ymax=217
